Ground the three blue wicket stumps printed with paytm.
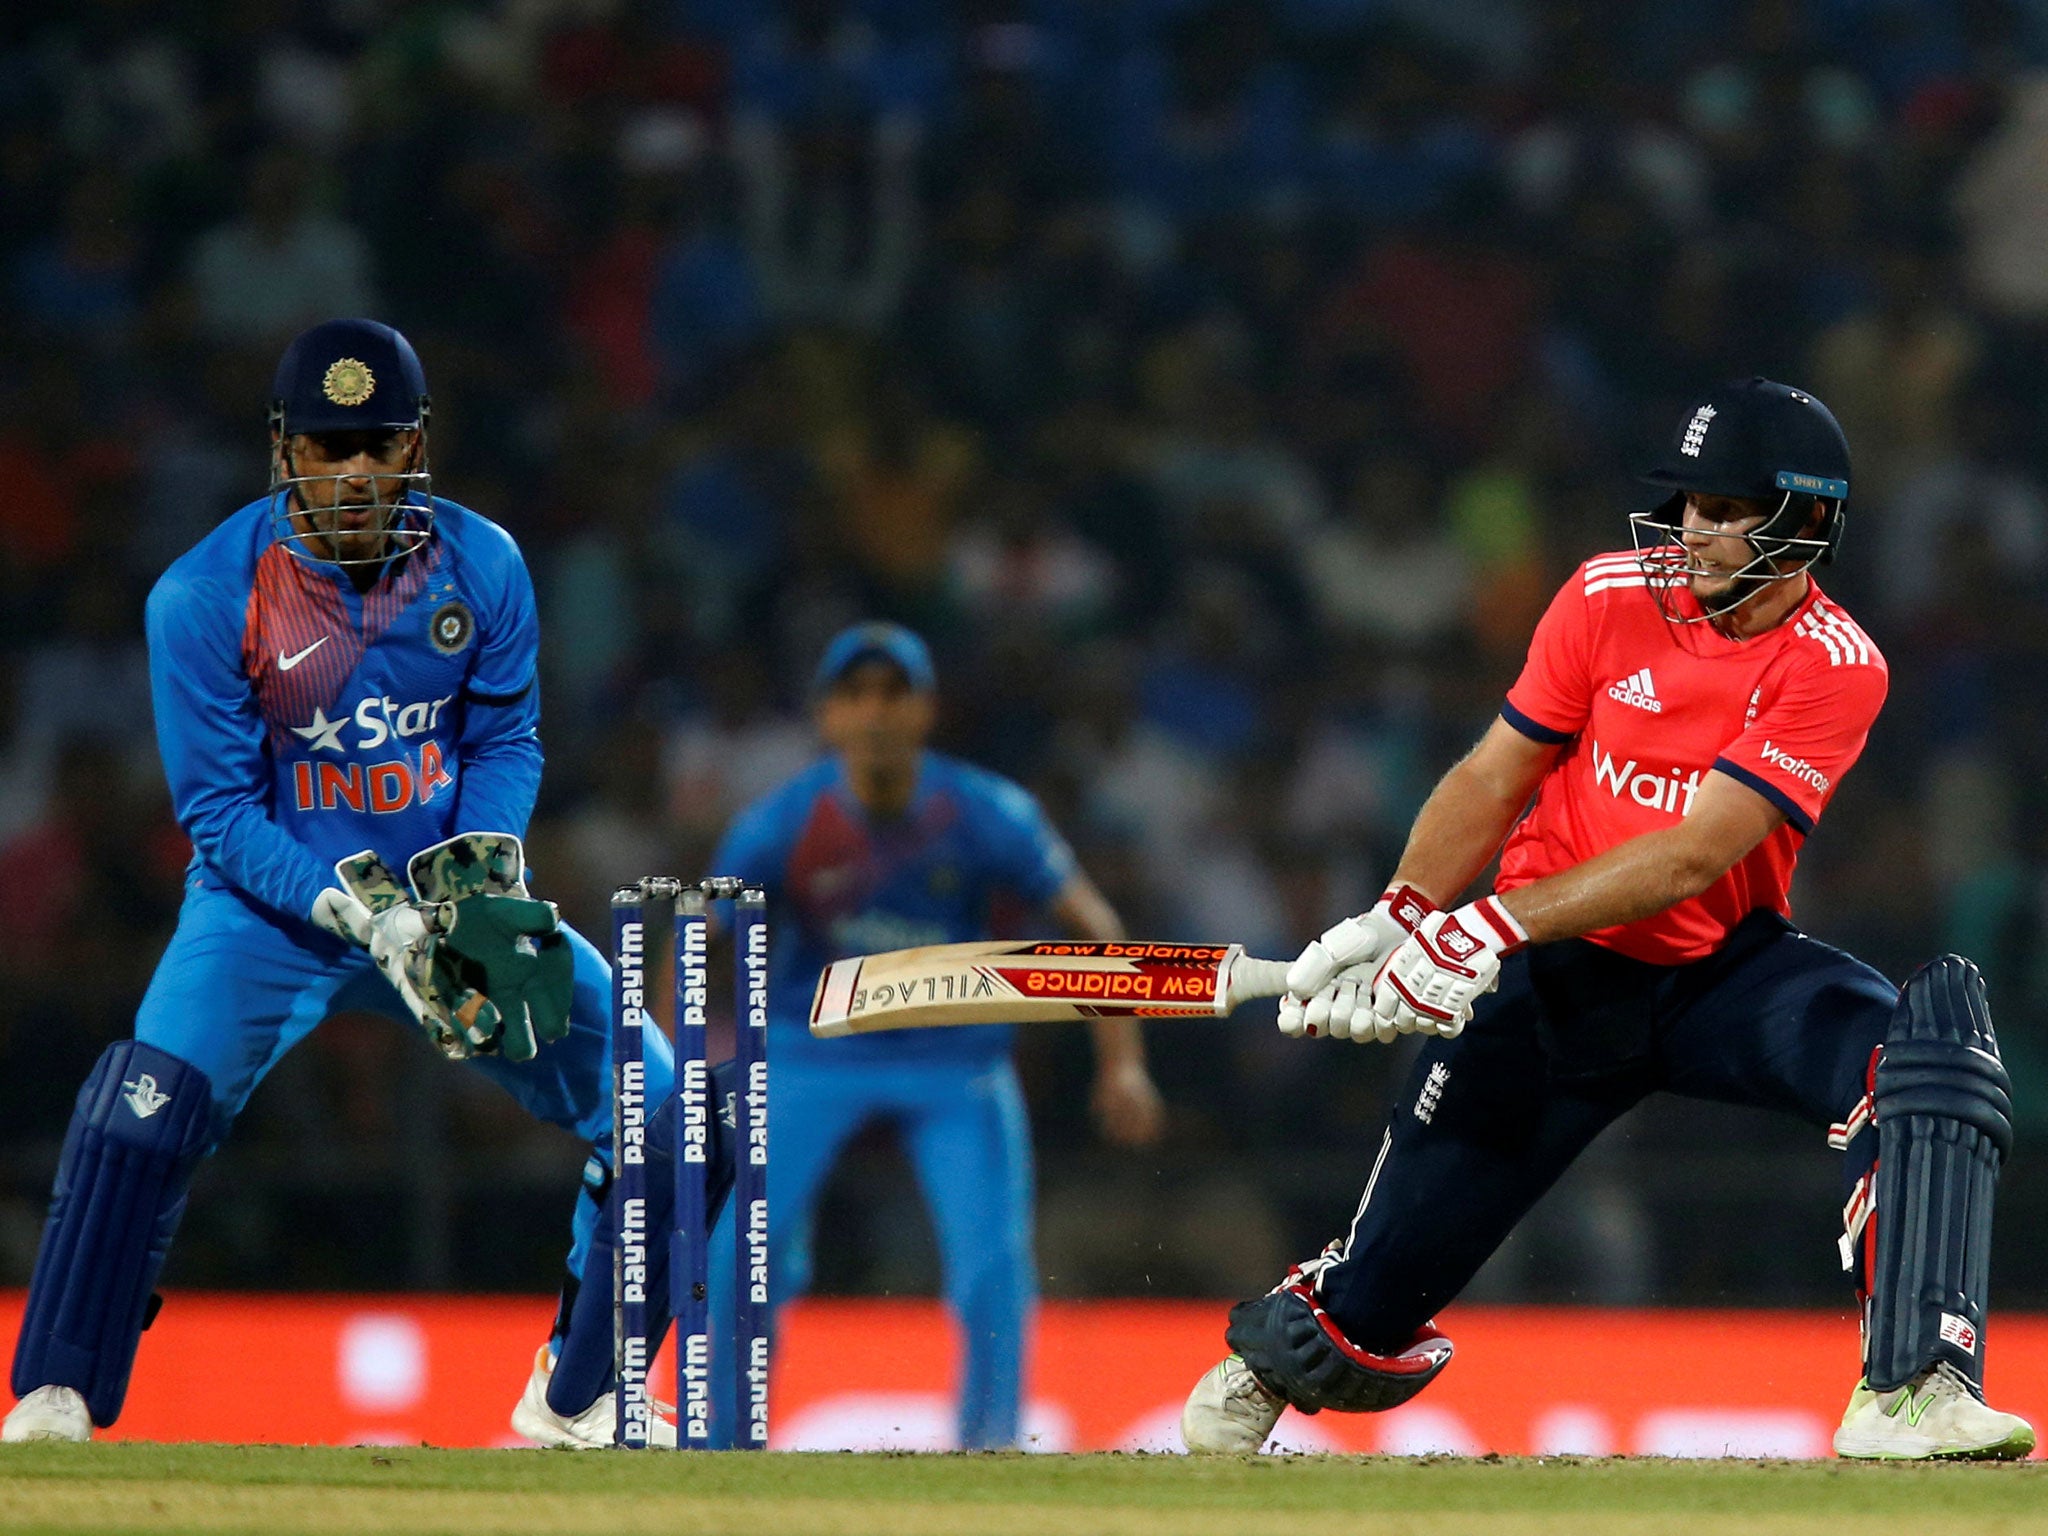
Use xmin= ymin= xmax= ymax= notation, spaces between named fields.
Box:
xmin=610 ymin=874 xmax=768 ymax=1450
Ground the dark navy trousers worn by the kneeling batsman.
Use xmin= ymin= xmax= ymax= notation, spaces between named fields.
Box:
xmin=1319 ymin=911 xmax=1898 ymax=1352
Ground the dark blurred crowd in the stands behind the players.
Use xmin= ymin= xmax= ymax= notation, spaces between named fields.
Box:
xmin=0 ymin=0 xmax=2048 ymax=1448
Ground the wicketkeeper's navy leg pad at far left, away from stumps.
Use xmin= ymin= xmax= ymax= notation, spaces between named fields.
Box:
xmin=12 ymin=1040 xmax=215 ymax=1427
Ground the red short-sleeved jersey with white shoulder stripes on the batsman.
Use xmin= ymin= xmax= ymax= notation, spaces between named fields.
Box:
xmin=1495 ymin=551 xmax=1886 ymax=965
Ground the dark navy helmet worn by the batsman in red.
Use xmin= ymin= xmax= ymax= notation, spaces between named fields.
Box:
xmin=1630 ymin=379 xmax=1849 ymax=575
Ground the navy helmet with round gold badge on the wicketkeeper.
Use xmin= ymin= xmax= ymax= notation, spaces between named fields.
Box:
xmin=270 ymin=319 xmax=434 ymax=565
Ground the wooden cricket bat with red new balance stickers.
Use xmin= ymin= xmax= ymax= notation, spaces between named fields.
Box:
xmin=811 ymin=940 xmax=1288 ymax=1038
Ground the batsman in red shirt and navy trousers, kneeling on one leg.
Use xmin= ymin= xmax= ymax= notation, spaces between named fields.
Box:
xmin=1182 ymin=379 xmax=2034 ymax=1460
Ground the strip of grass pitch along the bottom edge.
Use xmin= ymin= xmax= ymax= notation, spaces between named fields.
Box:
xmin=0 ymin=1444 xmax=2048 ymax=1536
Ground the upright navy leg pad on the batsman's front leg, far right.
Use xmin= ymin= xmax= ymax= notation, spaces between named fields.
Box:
xmin=1864 ymin=954 xmax=2013 ymax=1391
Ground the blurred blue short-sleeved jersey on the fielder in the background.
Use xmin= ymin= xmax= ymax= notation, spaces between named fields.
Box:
xmin=713 ymin=752 xmax=1075 ymax=1063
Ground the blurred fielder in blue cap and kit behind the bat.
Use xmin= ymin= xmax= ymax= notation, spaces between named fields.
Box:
xmin=713 ymin=623 xmax=1163 ymax=1450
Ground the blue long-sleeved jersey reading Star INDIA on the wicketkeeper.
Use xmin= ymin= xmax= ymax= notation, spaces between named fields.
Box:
xmin=147 ymin=498 xmax=541 ymax=920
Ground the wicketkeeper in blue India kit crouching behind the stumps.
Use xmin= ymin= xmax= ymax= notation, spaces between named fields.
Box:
xmin=0 ymin=319 xmax=731 ymax=1446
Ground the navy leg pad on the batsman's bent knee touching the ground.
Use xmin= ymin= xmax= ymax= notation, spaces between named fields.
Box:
xmin=1223 ymin=1282 xmax=1450 ymax=1413
